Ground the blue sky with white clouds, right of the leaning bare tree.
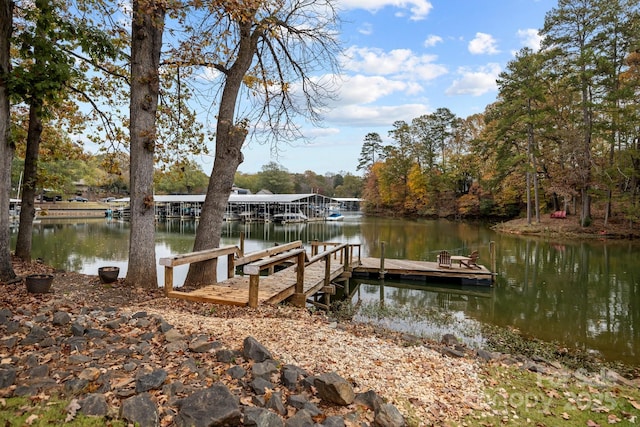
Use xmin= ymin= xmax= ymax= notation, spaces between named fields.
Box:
xmin=200 ymin=0 xmax=557 ymax=175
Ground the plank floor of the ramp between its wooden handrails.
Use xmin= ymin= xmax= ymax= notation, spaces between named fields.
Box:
xmin=168 ymin=260 xmax=344 ymax=306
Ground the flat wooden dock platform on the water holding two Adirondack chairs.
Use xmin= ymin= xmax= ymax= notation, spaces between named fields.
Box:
xmin=353 ymin=258 xmax=493 ymax=285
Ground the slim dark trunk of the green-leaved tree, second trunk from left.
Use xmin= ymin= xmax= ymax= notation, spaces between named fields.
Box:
xmin=16 ymin=100 xmax=42 ymax=261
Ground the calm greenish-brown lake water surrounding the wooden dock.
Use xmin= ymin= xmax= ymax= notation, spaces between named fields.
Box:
xmin=12 ymin=217 xmax=640 ymax=364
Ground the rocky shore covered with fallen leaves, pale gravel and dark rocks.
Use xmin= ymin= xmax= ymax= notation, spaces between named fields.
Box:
xmin=0 ymin=262 xmax=638 ymax=427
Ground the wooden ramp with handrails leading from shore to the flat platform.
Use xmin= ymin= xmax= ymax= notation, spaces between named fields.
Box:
xmin=160 ymin=241 xmax=360 ymax=307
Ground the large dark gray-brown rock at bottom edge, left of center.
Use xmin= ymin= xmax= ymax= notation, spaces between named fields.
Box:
xmin=174 ymin=384 xmax=242 ymax=427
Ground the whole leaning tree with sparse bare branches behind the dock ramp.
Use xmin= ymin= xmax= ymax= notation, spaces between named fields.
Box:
xmin=183 ymin=0 xmax=338 ymax=285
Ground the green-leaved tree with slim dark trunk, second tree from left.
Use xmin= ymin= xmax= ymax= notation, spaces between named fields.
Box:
xmin=9 ymin=0 xmax=121 ymax=260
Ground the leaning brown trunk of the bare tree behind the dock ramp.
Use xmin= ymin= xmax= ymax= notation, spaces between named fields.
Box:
xmin=185 ymin=19 xmax=258 ymax=286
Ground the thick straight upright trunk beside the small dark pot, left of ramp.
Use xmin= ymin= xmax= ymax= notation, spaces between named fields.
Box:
xmin=126 ymin=0 xmax=165 ymax=288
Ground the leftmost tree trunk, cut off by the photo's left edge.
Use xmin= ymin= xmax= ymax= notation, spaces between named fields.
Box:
xmin=0 ymin=0 xmax=16 ymax=282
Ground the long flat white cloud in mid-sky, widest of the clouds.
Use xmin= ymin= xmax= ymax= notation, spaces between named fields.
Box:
xmin=343 ymin=47 xmax=447 ymax=81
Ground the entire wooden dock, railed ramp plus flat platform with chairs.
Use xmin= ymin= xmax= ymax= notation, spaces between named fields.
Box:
xmin=160 ymin=241 xmax=494 ymax=308
